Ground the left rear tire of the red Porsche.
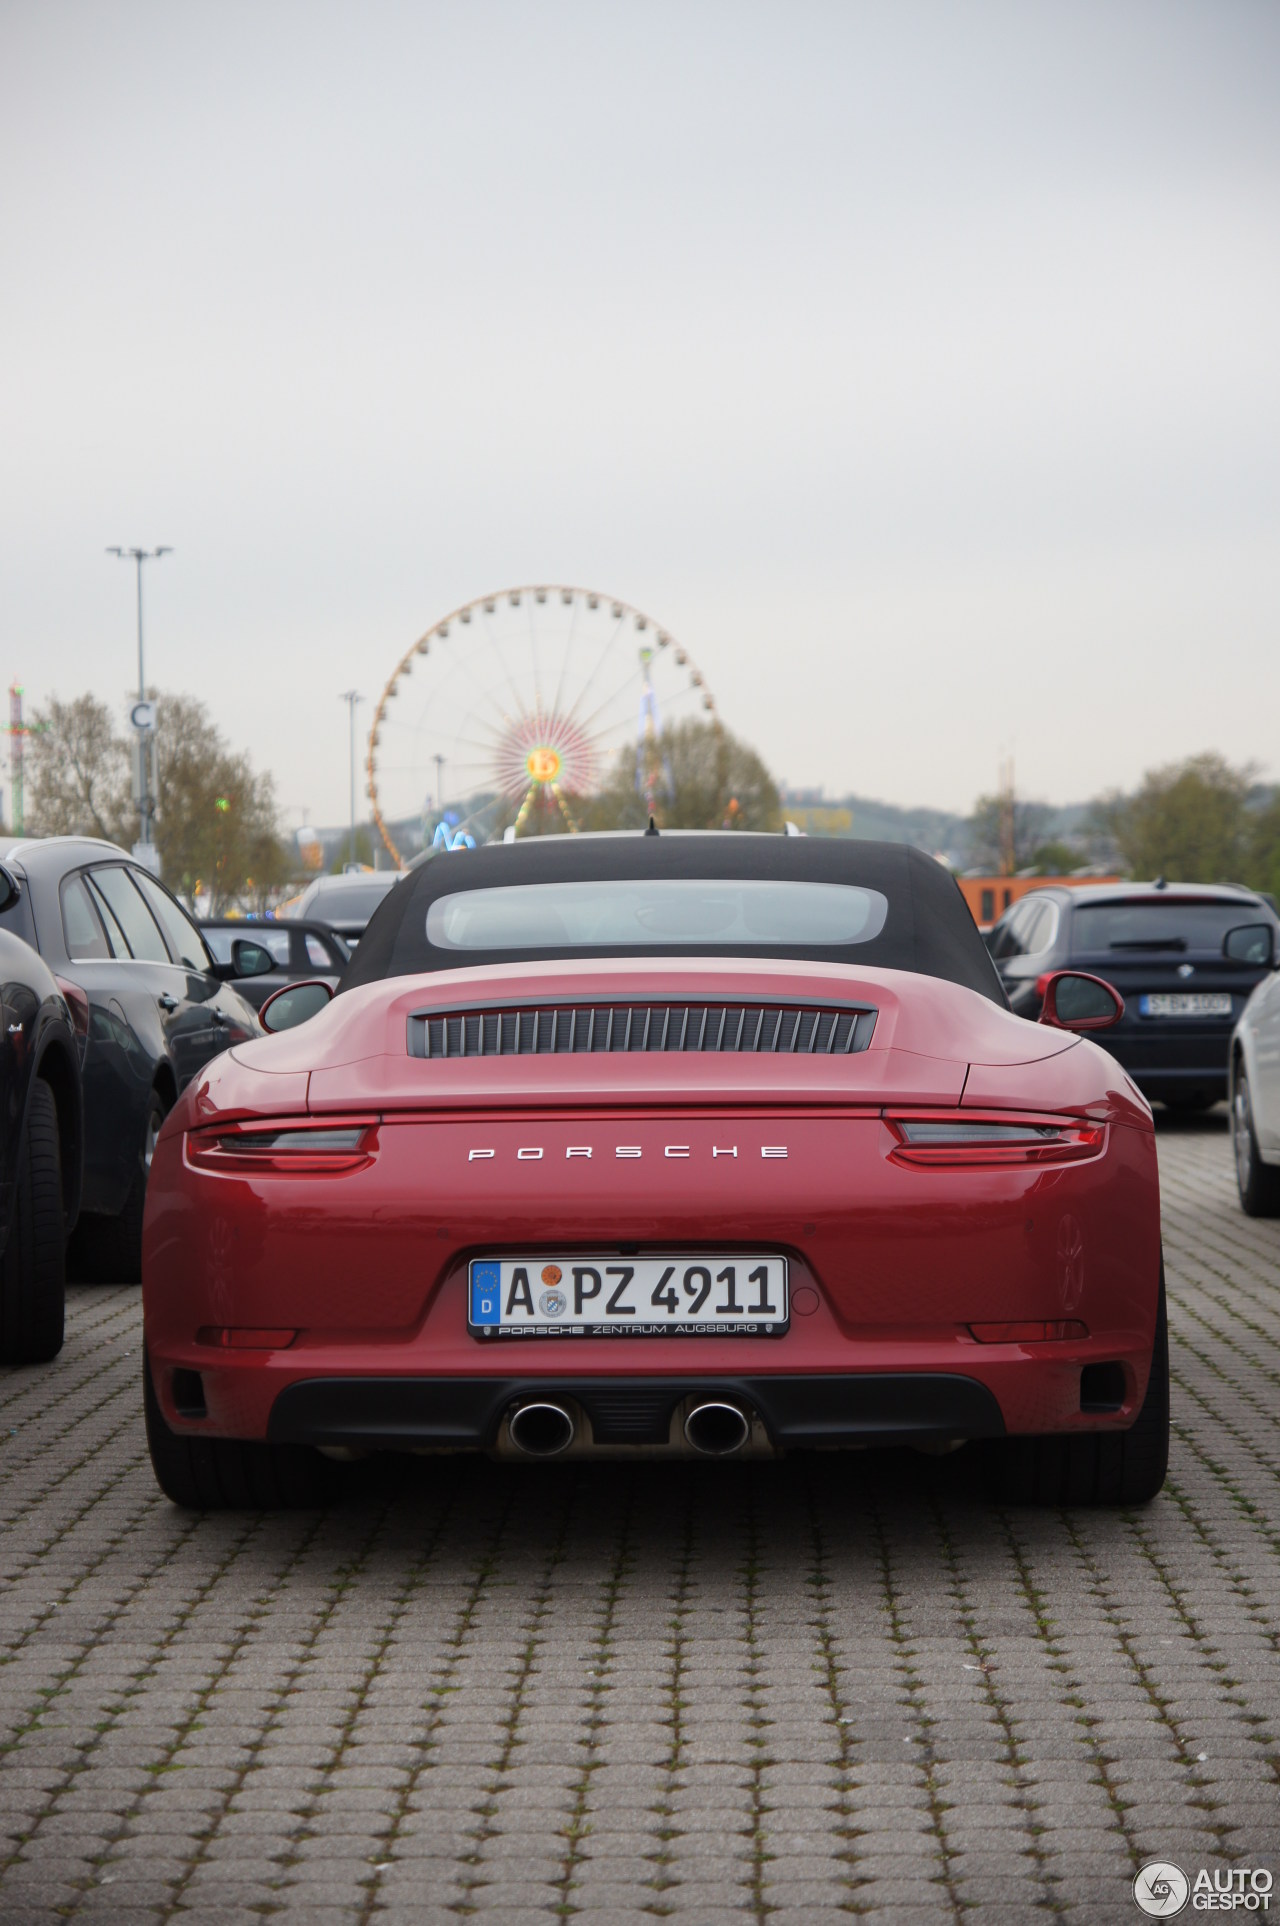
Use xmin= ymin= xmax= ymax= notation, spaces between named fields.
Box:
xmin=142 ymin=1354 xmax=341 ymax=1512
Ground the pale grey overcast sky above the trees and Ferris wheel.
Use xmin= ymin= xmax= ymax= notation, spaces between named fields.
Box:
xmin=0 ymin=0 xmax=1280 ymax=822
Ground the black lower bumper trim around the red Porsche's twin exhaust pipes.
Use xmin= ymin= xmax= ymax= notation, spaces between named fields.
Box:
xmin=268 ymin=1371 xmax=1005 ymax=1450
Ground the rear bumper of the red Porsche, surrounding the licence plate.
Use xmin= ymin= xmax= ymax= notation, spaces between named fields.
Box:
xmin=142 ymin=1109 xmax=1159 ymax=1448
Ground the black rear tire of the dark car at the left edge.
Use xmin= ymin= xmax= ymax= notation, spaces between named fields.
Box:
xmin=0 ymin=1079 xmax=67 ymax=1364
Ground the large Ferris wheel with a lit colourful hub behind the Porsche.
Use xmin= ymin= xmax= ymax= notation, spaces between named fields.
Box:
xmin=366 ymin=586 xmax=718 ymax=863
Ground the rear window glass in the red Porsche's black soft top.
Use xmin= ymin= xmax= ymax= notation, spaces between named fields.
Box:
xmin=427 ymin=876 xmax=889 ymax=950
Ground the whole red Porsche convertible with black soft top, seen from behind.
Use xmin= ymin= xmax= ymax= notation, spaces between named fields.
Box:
xmin=142 ymin=832 xmax=1168 ymax=1506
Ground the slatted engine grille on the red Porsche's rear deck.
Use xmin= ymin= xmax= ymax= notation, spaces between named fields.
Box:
xmin=408 ymin=1002 xmax=876 ymax=1057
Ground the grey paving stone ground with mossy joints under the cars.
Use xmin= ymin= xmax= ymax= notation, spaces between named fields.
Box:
xmin=0 ymin=1111 xmax=1280 ymax=1926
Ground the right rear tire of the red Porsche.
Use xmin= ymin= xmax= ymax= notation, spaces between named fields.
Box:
xmin=986 ymin=1271 xmax=1168 ymax=1506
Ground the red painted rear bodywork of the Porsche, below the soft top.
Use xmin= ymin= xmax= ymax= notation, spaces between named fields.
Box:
xmin=142 ymin=959 xmax=1161 ymax=1439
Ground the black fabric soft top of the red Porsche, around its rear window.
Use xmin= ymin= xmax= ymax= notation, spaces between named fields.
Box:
xmin=339 ymin=832 xmax=1007 ymax=1007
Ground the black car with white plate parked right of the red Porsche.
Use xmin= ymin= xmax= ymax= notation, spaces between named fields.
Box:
xmin=987 ymin=882 xmax=1280 ymax=1109
